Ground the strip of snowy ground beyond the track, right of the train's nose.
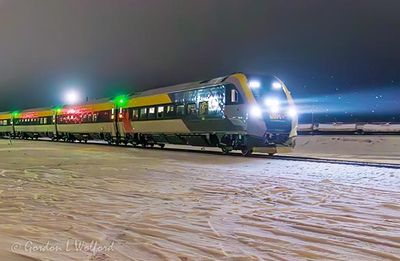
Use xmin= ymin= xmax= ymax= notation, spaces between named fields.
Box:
xmin=288 ymin=135 xmax=400 ymax=164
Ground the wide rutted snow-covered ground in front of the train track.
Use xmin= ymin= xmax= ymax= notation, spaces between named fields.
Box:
xmin=0 ymin=140 xmax=400 ymax=260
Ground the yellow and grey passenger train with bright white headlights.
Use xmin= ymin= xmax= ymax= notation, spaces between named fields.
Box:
xmin=0 ymin=73 xmax=298 ymax=156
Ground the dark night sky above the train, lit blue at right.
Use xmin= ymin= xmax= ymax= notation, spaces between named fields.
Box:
xmin=0 ymin=0 xmax=400 ymax=121
